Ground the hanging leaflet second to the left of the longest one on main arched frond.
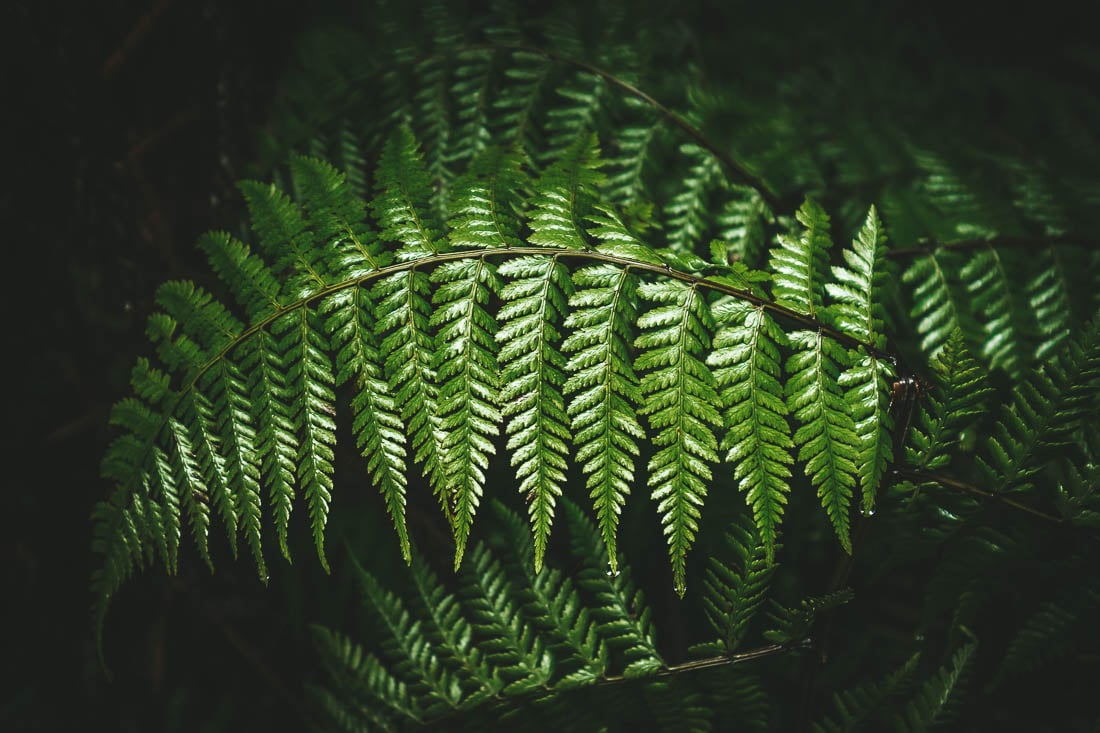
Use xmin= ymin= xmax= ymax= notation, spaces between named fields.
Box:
xmin=496 ymin=256 xmax=573 ymax=568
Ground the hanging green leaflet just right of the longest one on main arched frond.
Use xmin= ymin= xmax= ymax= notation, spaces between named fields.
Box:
xmin=707 ymin=300 xmax=794 ymax=562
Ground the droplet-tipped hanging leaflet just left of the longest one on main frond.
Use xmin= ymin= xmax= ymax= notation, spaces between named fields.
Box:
xmin=562 ymin=259 xmax=645 ymax=571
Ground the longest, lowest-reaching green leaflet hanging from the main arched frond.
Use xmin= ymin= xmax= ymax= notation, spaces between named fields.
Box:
xmin=635 ymin=281 xmax=722 ymax=595
